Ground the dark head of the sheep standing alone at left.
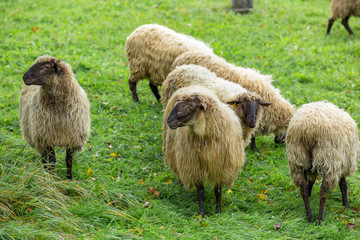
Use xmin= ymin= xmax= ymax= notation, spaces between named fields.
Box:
xmin=23 ymin=58 xmax=62 ymax=86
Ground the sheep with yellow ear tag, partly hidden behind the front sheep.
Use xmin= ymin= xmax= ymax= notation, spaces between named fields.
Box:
xmin=161 ymin=65 xmax=271 ymax=147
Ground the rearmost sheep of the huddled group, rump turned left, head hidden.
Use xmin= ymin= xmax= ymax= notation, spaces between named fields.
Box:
xmin=125 ymin=24 xmax=213 ymax=102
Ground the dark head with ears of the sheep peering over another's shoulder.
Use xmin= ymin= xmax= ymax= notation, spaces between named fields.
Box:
xmin=227 ymin=97 xmax=271 ymax=128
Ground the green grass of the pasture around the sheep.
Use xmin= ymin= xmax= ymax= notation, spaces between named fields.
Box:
xmin=0 ymin=0 xmax=360 ymax=239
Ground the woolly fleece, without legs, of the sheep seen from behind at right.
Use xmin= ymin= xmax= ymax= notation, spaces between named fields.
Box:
xmin=286 ymin=102 xmax=360 ymax=188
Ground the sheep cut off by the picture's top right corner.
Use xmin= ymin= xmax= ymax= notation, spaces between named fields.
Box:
xmin=326 ymin=0 xmax=360 ymax=35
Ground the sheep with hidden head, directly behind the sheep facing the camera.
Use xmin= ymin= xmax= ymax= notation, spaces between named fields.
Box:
xmin=171 ymin=51 xmax=295 ymax=151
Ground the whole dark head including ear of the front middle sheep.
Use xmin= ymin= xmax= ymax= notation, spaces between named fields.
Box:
xmin=167 ymin=95 xmax=207 ymax=129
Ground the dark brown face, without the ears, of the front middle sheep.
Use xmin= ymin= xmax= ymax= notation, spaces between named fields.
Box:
xmin=167 ymin=102 xmax=198 ymax=129
